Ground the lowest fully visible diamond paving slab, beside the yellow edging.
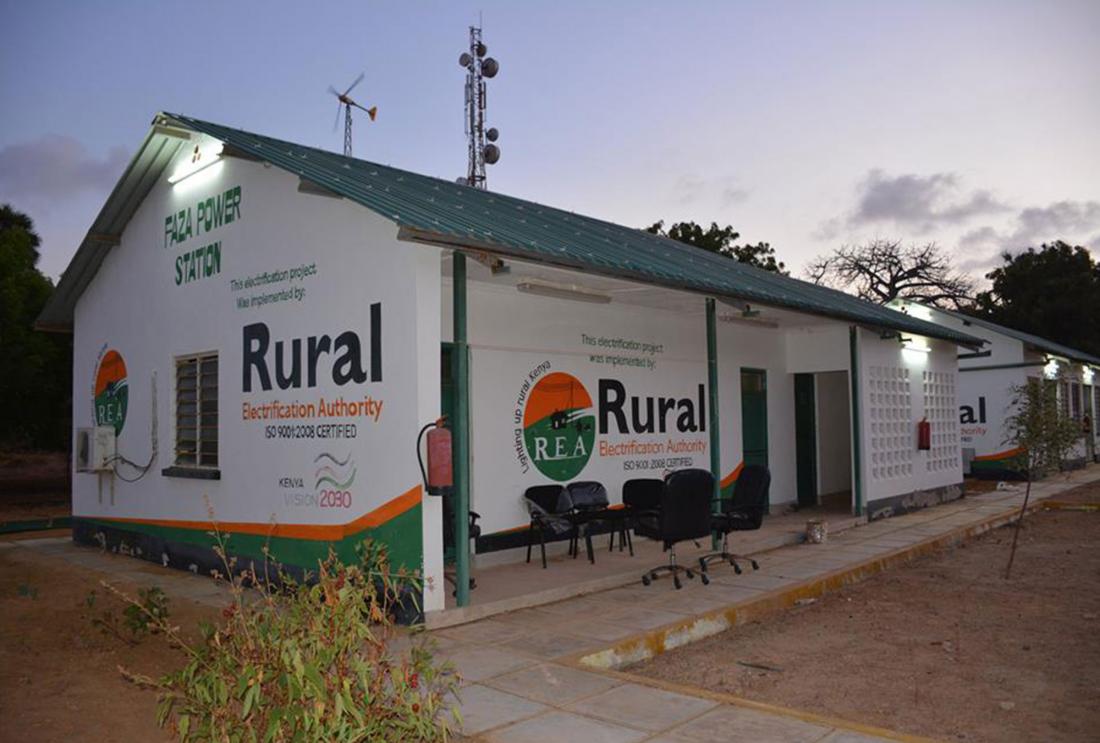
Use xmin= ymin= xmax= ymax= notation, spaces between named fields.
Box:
xmin=568 ymin=684 xmax=718 ymax=733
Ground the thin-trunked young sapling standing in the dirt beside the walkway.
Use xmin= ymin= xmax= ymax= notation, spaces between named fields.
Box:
xmin=1004 ymin=379 xmax=1081 ymax=579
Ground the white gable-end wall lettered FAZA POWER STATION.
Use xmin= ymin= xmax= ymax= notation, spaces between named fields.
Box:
xmin=73 ymin=147 xmax=439 ymax=603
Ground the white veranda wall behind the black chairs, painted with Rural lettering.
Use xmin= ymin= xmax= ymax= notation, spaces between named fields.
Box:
xmin=442 ymin=281 xmax=809 ymax=561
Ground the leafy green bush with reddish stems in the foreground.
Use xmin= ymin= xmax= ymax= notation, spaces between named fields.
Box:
xmin=120 ymin=535 xmax=459 ymax=742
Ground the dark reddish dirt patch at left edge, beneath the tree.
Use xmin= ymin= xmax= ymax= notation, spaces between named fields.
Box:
xmin=0 ymin=452 xmax=70 ymax=523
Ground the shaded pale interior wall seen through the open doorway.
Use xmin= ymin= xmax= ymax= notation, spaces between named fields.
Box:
xmin=814 ymin=372 xmax=851 ymax=495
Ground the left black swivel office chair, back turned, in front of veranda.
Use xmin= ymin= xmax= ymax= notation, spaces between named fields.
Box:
xmin=634 ymin=469 xmax=714 ymax=590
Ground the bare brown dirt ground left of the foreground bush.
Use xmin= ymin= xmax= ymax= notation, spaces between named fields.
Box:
xmin=0 ymin=549 xmax=217 ymax=743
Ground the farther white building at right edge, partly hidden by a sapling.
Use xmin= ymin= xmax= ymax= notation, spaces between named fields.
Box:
xmin=895 ymin=302 xmax=1100 ymax=479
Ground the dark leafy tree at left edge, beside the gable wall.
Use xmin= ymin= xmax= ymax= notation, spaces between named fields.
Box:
xmin=0 ymin=205 xmax=73 ymax=449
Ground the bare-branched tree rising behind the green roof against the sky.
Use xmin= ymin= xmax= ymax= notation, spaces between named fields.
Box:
xmin=805 ymin=240 xmax=975 ymax=307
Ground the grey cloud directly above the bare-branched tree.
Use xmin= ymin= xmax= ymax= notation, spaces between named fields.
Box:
xmin=846 ymin=170 xmax=1009 ymax=232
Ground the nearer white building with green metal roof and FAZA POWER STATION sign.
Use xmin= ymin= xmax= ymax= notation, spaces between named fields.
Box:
xmin=40 ymin=114 xmax=980 ymax=611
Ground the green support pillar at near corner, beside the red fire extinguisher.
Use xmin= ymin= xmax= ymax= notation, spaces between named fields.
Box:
xmin=452 ymin=251 xmax=470 ymax=607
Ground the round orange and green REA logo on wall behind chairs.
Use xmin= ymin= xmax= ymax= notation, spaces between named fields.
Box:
xmin=524 ymin=372 xmax=596 ymax=482
